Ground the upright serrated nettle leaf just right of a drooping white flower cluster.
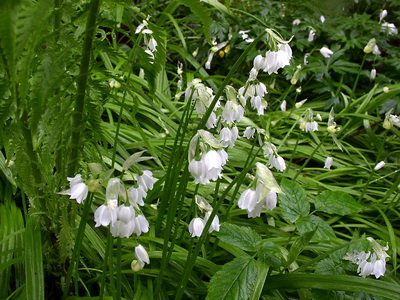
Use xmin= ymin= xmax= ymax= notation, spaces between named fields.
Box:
xmin=279 ymin=178 xmax=310 ymax=223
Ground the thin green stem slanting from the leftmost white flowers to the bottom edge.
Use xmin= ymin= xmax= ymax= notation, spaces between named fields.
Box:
xmin=62 ymin=193 xmax=94 ymax=300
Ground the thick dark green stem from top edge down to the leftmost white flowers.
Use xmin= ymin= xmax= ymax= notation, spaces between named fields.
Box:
xmin=67 ymin=0 xmax=100 ymax=176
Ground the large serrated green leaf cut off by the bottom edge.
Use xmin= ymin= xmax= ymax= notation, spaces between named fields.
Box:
xmin=206 ymin=256 xmax=257 ymax=300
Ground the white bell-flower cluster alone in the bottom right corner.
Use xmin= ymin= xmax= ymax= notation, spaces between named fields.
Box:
xmin=343 ymin=237 xmax=389 ymax=279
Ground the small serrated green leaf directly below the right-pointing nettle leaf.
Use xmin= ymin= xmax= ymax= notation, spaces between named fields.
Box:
xmin=296 ymin=215 xmax=335 ymax=240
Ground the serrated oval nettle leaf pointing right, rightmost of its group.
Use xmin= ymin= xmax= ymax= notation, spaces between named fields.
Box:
xmin=315 ymin=191 xmax=363 ymax=216
